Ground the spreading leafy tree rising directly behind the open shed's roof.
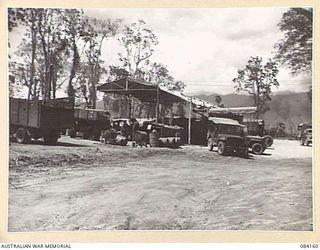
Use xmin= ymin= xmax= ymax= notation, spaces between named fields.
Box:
xmin=109 ymin=20 xmax=185 ymax=91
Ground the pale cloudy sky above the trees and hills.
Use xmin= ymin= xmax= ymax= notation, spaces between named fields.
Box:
xmin=10 ymin=8 xmax=311 ymax=95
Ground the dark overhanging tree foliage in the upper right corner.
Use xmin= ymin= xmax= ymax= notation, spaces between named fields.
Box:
xmin=275 ymin=8 xmax=313 ymax=75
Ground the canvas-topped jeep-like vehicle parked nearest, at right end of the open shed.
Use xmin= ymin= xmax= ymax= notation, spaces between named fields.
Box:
xmin=207 ymin=117 xmax=248 ymax=157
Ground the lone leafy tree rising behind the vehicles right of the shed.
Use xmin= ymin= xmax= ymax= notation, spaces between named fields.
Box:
xmin=233 ymin=57 xmax=279 ymax=115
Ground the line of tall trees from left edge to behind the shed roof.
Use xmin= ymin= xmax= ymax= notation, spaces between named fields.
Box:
xmin=8 ymin=8 xmax=185 ymax=108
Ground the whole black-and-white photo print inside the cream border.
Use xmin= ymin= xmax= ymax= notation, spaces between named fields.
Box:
xmin=6 ymin=6 xmax=315 ymax=232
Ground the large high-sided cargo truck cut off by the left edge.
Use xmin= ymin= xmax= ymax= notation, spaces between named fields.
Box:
xmin=9 ymin=98 xmax=74 ymax=145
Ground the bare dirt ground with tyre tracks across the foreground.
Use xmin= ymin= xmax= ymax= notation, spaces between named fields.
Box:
xmin=8 ymin=137 xmax=313 ymax=232
